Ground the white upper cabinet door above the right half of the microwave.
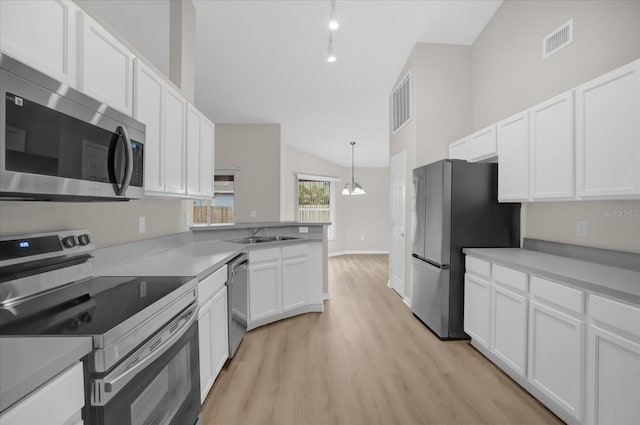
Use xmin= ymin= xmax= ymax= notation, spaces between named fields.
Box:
xmin=78 ymin=12 xmax=134 ymax=115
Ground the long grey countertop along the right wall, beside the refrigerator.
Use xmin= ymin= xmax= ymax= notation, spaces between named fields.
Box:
xmin=462 ymin=248 xmax=640 ymax=305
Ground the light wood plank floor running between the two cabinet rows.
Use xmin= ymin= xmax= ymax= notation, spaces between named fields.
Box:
xmin=202 ymin=255 xmax=562 ymax=425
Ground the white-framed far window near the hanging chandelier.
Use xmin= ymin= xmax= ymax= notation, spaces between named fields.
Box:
xmin=297 ymin=174 xmax=339 ymax=240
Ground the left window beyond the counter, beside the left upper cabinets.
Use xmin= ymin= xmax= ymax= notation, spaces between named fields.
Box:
xmin=193 ymin=175 xmax=235 ymax=225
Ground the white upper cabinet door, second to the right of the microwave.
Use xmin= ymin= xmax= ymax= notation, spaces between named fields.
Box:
xmin=164 ymin=87 xmax=186 ymax=194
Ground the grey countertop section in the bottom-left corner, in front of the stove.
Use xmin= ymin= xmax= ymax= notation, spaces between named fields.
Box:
xmin=0 ymin=336 xmax=93 ymax=412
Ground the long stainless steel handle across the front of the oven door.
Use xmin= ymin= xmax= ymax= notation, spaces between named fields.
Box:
xmin=91 ymin=305 xmax=199 ymax=406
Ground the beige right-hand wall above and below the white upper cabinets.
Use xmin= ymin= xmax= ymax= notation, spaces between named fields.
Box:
xmin=472 ymin=1 xmax=640 ymax=252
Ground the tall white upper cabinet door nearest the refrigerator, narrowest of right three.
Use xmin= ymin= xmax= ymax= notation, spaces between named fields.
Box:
xmin=497 ymin=112 xmax=529 ymax=202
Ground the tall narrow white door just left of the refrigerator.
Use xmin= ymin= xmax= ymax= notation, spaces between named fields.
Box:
xmin=389 ymin=151 xmax=407 ymax=298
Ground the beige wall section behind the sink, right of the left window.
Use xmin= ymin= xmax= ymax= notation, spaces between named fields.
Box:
xmin=215 ymin=124 xmax=281 ymax=223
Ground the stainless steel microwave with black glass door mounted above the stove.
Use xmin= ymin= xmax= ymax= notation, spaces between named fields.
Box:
xmin=0 ymin=53 xmax=145 ymax=201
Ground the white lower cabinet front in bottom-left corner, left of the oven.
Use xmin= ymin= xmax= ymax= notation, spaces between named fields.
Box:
xmin=0 ymin=362 xmax=84 ymax=425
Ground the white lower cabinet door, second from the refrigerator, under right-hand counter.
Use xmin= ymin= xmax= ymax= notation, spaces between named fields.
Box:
xmin=491 ymin=284 xmax=528 ymax=376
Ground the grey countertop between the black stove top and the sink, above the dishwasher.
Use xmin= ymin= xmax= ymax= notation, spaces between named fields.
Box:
xmin=101 ymin=241 xmax=246 ymax=279
